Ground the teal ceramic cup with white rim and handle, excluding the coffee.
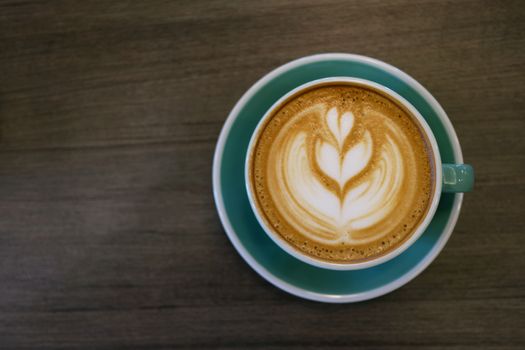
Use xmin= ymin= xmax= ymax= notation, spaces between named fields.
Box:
xmin=244 ymin=77 xmax=474 ymax=270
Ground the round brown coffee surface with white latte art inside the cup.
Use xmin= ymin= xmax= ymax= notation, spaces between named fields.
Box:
xmin=248 ymin=83 xmax=435 ymax=263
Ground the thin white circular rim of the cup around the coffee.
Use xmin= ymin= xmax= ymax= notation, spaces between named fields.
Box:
xmin=244 ymin=76 xmax=442 ymax=271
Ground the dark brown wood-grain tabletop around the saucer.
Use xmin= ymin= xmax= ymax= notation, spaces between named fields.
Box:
xmin=0 ymin=0 xmax=525 ymax=349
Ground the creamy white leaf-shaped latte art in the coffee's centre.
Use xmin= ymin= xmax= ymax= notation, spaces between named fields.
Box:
xmin=278 ymin=106 xmax=408 ymax=243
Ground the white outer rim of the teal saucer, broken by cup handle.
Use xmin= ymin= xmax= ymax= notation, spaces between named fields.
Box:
xmin=212 ymin=53 xmax=463 ymax=303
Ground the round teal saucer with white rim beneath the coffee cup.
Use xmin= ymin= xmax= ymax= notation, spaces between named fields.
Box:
xmin=213 ymin=54 xmax=463 ymax=303
